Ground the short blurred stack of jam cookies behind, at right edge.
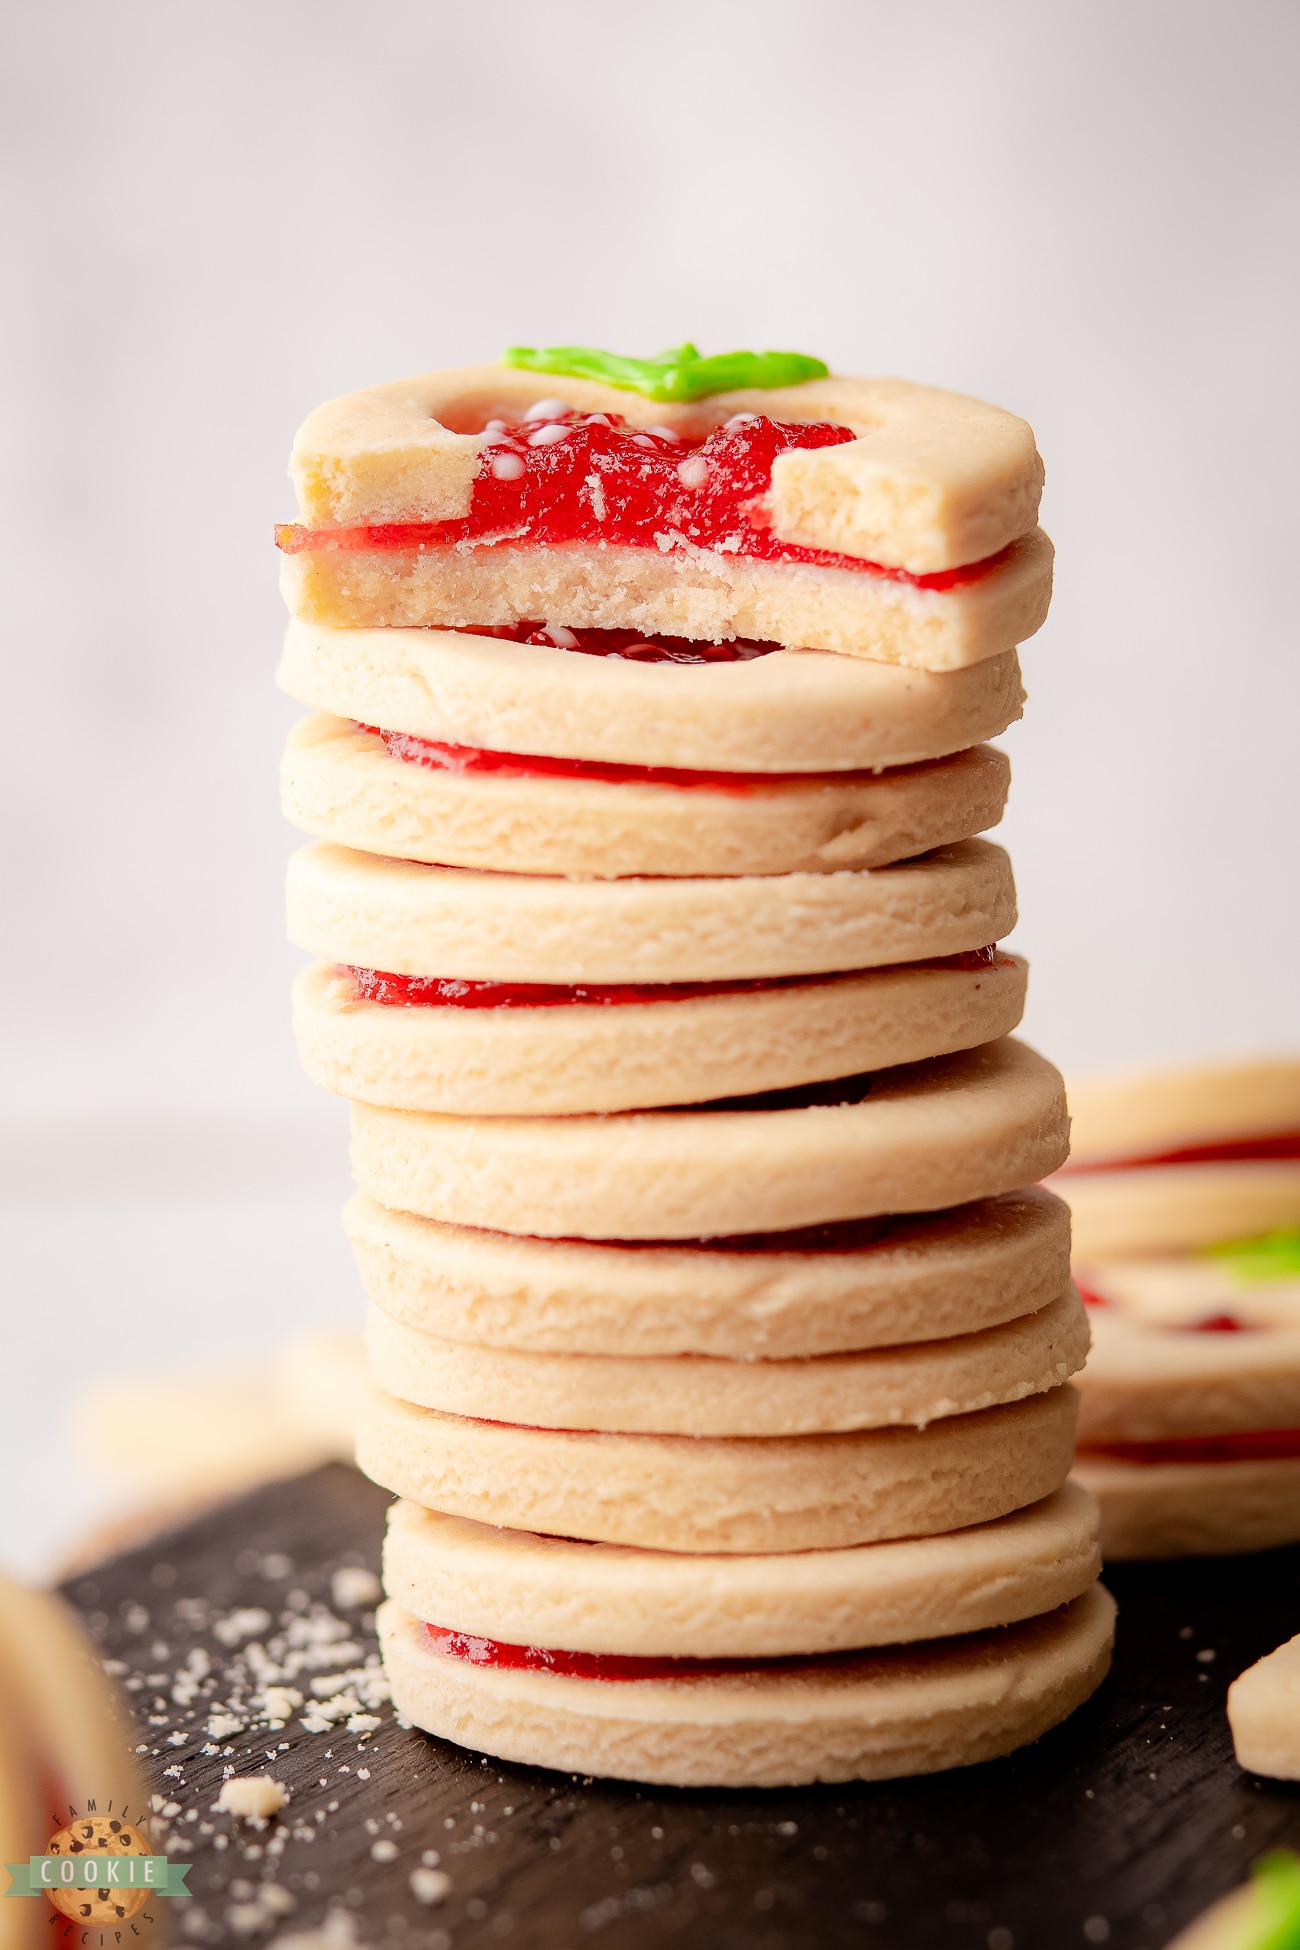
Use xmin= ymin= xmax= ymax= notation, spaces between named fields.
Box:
xmin=1058 ymin=1057 xmax=1300 ymax=1558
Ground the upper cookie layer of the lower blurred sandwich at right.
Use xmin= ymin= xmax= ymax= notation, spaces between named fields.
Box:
xmin=1080 ymin=1307 xmax=1300 ymax=1443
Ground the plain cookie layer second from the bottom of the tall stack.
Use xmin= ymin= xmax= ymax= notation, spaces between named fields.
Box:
xmin=384 ymin=1484 xmax=1101 ymax=1659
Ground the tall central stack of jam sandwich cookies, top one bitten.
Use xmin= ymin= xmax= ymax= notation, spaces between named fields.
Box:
xmin=279 ymin=347 xmax=1113 ymax=1784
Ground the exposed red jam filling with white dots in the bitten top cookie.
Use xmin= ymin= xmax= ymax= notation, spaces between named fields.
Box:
xmin=275 ymin=413 xmax=998 ymax=589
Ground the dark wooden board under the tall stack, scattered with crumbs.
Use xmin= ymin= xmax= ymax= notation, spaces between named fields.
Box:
xmin=66 ymin=1464 xmax=1300 ymax=1950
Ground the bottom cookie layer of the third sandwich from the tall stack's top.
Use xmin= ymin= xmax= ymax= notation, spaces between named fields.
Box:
xmin=292 ymin=954 xmax=1027 ymax=1117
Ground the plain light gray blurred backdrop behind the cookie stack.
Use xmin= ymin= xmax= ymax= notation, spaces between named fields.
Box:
xmin=0 ymin=0 xmax=1300 ymax=1566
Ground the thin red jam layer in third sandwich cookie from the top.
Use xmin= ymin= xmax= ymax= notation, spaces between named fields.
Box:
xmin=343 ymin=948 xmax=1010 ymax=1014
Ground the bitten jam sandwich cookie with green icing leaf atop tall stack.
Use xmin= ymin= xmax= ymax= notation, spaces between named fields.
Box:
xmin=279 ymin=349 xmax=1052 ymax=671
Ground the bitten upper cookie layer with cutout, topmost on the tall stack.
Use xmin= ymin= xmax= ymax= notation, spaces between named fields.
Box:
xmin=288 ymin=365 xmax=1043 ymax=573
